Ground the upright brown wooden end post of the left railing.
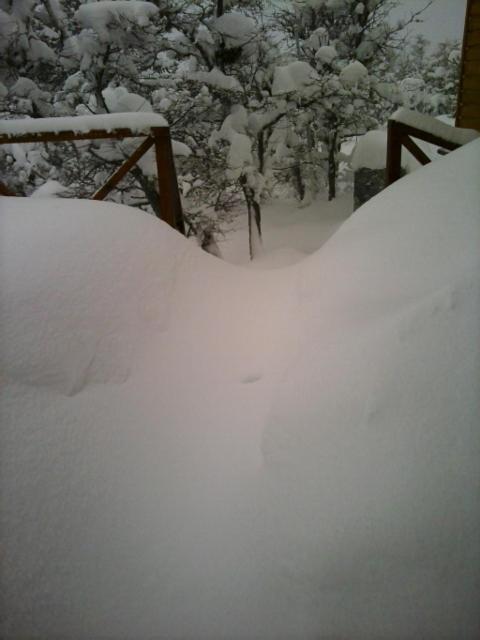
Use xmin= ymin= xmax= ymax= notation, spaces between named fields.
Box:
xmin=152 ymin=127 xmax=185 ymax=234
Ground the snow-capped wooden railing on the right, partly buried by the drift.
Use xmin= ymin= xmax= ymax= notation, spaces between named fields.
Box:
xmin=386 ymin=109 xmax=480 ymax=186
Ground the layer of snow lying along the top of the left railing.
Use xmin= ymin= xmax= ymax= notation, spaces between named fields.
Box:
xmin=0 ymin=112 xmax=168 ymax=136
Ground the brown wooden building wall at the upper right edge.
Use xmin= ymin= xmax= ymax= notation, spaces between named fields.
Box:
xmin=455 ymin=0 xmax=480 ymax=131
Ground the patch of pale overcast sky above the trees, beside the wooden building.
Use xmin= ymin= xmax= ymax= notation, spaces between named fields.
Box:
xmin=392 ymin=0 xmax=467 ymax=42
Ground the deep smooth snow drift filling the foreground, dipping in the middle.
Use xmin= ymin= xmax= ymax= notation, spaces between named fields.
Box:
xmin=0 ymin=141 xmax=480 ymax=640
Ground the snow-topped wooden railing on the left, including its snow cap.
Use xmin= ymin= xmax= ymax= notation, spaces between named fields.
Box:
xmin=0 ymin=113 xmax=184 ymax=233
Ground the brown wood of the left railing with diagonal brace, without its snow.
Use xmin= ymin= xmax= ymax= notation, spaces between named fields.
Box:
xmin=0 ymin=127 xmax=185 ymax=233
